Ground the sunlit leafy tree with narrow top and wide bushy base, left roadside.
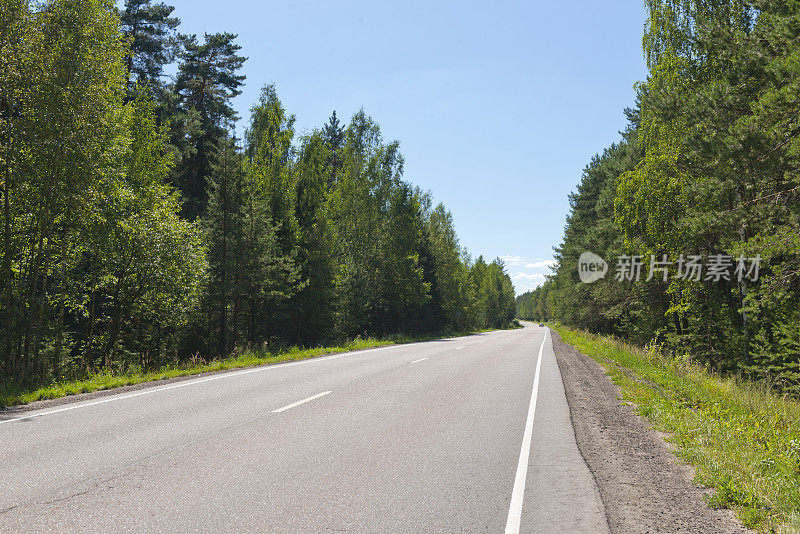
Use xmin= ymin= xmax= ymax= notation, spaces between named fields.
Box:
xmin=89 ymin=89 xmax=206 ymax=367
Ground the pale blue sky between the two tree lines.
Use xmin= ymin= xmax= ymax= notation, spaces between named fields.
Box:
xmin=158 ymin=0 xmax=645 ymax=293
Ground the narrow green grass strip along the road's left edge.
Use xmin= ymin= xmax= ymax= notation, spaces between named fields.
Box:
xmin=0 ymin=330 xmax=512 ymax=407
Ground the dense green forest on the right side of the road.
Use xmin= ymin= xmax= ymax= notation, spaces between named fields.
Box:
xmin=517 ymin=0 xmax=800 ymax=393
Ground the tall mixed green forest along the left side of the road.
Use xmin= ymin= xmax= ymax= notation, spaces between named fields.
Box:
xmin=0 ymin=0 xmax=515 ymax=394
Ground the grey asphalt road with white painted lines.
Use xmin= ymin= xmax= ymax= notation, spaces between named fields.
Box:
xmin=0 ymin=325 xmax=608 ymax=533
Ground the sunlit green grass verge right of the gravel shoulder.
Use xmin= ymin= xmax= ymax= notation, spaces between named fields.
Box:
xmin=553 ymin=326 xmax=800 ymax=533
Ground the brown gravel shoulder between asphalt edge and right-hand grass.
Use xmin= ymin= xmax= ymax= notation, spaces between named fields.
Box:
xmin=551 ymin=330 xmax=752 ymax=534
